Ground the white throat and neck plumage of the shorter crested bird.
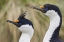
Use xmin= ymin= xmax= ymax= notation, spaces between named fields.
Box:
xmin=18 ymin=25 xmax=34 ymax=42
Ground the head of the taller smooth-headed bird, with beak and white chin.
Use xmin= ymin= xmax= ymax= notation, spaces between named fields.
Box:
xmin=32 ymin=4 xmax=60 ymax=16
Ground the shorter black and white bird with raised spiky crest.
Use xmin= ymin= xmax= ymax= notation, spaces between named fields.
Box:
xmin=7 ymin=13 xmax=34 ymax=42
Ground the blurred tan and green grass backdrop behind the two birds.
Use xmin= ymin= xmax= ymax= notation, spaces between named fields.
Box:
xmin=0 ymin=0 xmax=64 ymax=42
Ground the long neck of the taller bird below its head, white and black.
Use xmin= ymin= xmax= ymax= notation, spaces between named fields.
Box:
xmin=43 ymin=14 xmax=62 ymax=42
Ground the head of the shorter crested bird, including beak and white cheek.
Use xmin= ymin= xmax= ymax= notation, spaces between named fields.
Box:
xmin=7 ymin=12 xmax=33 ymax=32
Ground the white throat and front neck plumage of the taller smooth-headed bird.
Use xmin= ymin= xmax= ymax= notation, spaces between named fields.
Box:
xmin=43 ymin=10 xmax=60 ymax=42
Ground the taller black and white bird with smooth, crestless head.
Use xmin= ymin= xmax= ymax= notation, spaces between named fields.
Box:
xmin=32 ymin=4 xmax=63 ymax=42
